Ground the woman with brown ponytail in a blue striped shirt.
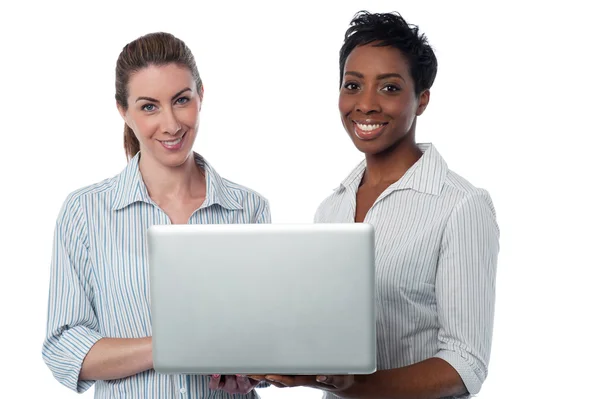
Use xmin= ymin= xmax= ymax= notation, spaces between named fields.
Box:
xmin=43 ymin=33 xmax=271 ymax=399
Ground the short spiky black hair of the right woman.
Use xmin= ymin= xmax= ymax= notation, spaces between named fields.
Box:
xmin=340 ymin=11 xmax=437 ymax=95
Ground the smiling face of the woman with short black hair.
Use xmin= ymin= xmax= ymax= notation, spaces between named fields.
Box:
xmin=339 ymin=44 xmax=429 ymax=155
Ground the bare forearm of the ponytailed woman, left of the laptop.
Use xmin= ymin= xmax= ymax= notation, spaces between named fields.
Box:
xmin=79 ymin=337 xmax=153 ymax=381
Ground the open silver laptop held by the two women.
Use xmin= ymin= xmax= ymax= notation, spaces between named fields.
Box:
xmin=148 ymin=223 xmax=376 ymax=375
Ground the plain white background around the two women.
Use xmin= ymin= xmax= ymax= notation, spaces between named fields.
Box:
xmin=0 ymin=0 xmax=600 ymax=399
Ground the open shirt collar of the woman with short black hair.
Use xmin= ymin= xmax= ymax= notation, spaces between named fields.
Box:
xmin=336 ymin=143 xmax=448 ymax=195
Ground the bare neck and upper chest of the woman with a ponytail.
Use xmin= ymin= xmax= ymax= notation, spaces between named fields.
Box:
xmin=139 ymin=153 xmax=206 ymax=202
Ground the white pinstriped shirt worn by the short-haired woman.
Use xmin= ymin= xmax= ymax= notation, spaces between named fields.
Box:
xmin=315 ymin=144 xmax=500 ymax=399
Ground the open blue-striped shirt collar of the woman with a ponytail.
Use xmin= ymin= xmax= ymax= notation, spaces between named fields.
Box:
xmin=112 ymin=152 xmax=243 ymax=210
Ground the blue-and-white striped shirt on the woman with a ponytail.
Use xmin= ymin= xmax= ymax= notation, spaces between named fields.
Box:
xmin=42 ymin=153 xmax=271 ymax=399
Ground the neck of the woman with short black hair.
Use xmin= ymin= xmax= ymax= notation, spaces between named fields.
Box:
xmin=361 ymin=133 xmax=423 ymax=186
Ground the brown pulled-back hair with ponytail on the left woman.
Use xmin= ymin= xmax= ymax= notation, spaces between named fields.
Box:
xmin=115 ymin=32 xmax=202 ymax=160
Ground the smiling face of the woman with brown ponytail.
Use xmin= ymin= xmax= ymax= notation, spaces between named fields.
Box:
xmin=118 ymin=64 xmax=202 ymax=167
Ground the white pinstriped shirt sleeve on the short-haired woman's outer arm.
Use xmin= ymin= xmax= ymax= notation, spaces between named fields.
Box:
xmin=435 ymin=190 xmax=500 ymax=395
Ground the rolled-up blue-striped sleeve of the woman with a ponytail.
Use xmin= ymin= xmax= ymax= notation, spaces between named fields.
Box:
xmin=42 ymin=194 xmax=102 ymax=393
